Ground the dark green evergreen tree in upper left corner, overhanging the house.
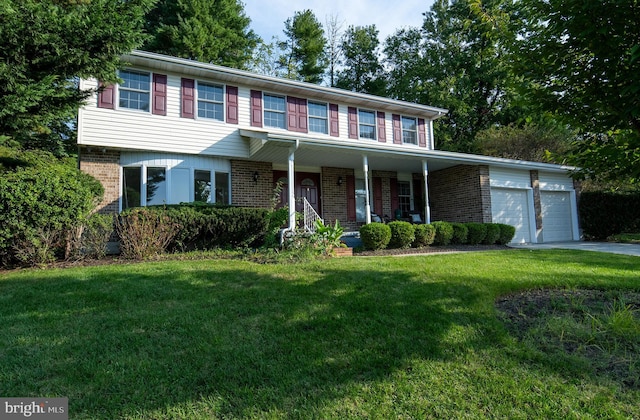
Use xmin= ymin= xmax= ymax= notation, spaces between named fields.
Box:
xmin=0 ymin=0 xmax=153 ymax=156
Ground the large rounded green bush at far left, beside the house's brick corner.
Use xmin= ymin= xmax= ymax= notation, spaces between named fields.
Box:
xmin=0 ymin=147 xmax=104 ymax=265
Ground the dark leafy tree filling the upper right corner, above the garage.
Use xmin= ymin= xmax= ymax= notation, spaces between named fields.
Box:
xmin=517 ymin=0 xmax=640 ymax=181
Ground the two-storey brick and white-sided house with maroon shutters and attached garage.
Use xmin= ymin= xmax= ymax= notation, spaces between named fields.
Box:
xmin=78 ymin=51 xmax=579 ymax=242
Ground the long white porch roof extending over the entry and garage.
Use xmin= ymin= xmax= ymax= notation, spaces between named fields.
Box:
xmin=240 ymin=129 xmax=576 ymax=173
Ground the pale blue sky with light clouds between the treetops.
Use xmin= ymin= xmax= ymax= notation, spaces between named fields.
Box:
xmin=242 ymin=0 xmax=433 ymax=43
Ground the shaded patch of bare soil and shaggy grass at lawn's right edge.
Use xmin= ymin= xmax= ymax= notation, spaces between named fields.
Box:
xmin=496 ymin=289 xmax=640 ymax=389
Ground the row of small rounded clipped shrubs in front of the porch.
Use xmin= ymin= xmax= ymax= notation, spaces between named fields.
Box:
xmin=360 ymin=221 xmax=516 ymax=250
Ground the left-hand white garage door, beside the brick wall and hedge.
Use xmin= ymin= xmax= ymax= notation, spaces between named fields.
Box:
xmin=491 ymin=188 xmax=531 ymax=243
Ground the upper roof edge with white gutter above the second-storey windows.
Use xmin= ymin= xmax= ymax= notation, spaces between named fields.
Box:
xmin=122 ymin=50 xmax=449 ymax=120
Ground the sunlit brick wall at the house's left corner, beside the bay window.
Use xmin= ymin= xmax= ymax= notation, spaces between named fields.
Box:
xmin=79 ymin=147 xmax=120 ymax=213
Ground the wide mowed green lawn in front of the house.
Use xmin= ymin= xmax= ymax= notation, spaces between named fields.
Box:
xmin=0 ymin=250 xmax=640 ymax=419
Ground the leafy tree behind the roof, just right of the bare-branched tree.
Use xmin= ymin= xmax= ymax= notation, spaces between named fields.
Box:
xmin=336 ymin=25 xmax=385 ymax=95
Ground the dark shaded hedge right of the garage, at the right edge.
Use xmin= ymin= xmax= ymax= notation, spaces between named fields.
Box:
xmin=578 ymin=191 xmax=640 ymax=239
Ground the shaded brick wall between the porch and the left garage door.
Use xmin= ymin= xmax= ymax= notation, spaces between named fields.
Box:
xmin=429 ymin=165 xmax=491 ymax=223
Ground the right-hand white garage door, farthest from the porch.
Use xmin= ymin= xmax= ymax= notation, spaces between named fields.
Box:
xmin=540 ymin=191 xmax=573 ymax=242
